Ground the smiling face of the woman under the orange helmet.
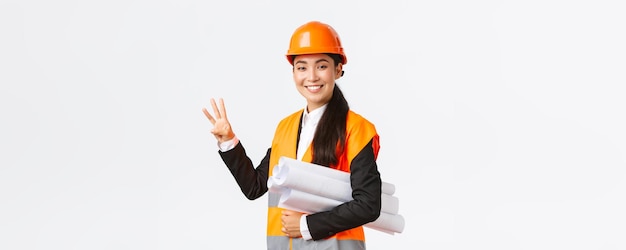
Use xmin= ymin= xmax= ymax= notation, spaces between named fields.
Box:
xmin=293 ymin=54 xmax=342 ymax=111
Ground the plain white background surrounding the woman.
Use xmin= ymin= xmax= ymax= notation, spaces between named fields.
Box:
xmin=0 ymin=0 xmax=626 ymax=250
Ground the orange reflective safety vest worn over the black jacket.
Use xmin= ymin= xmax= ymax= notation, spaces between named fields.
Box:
xmin=267 ymin=110 xmax=379 ymax=250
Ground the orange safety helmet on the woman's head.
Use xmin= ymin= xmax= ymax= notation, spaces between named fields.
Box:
xmin=287 ymin=21 xmax=348 ymax=65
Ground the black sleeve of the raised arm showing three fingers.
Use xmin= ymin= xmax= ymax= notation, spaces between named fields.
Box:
xmin=218 ymin=141 xmax=271 ymax=200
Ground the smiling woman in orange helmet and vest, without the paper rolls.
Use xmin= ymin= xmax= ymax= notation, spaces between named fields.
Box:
xmin=203 ymin=21 xmax=381 ymax=249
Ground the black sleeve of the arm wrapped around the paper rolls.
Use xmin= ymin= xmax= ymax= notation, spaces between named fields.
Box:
xmin=306 ymin=139 xmax=382 ymax=240
